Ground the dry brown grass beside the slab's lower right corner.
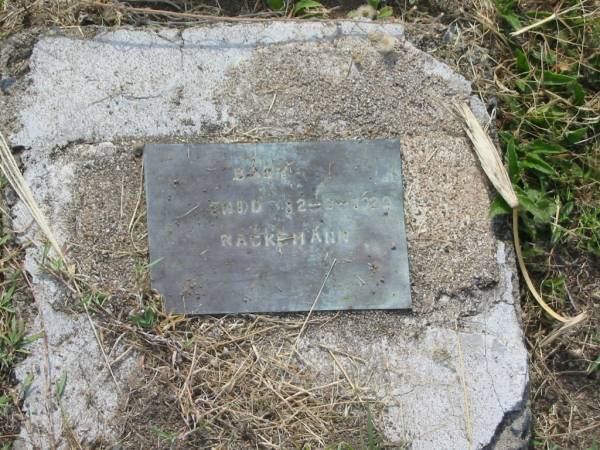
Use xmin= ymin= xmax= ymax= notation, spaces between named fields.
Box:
xmin=523 ymin=249 xmax=600 ymax=449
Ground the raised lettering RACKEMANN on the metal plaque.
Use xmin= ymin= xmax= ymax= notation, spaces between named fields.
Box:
xmin=220 ymin=227 xmax=350 ymax=248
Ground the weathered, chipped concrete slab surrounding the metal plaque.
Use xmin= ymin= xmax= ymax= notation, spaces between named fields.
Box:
xmin=3 ymin=22 xmax=528 ymax=449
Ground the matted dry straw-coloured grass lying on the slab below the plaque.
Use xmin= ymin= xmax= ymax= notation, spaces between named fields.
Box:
xmin=104 ymin=308 xmax=373 ymax=449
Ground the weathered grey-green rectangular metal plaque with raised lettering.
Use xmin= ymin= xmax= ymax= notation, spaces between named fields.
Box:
xmin=144 ymin=140 xmax=411 ymax=314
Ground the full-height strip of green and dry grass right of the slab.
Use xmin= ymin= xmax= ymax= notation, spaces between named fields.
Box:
xmin=492 ymin=0 xmax=600 ymax=450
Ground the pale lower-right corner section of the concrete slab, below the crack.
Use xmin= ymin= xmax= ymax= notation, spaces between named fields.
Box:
xmin=299 ymin=241 xmax=530 ymax=450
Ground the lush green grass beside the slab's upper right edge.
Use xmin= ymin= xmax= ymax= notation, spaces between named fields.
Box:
xmin=496 ymin=0 xmax=600 ymax=256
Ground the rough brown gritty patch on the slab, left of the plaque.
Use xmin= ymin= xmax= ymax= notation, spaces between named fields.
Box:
xmin=55 ymin=144 xmax=147 ymax=292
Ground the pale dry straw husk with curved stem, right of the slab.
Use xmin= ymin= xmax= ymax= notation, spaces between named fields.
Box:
xmin=454 ymin=103 xmax=587 ymax=332
